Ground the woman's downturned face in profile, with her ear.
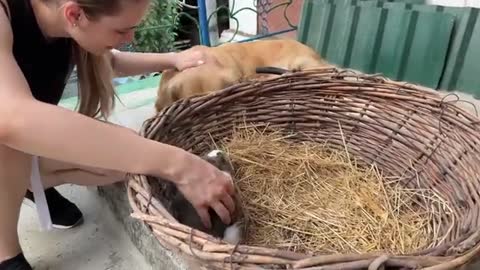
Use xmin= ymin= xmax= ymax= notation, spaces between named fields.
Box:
xmin=66 ymin=0 xmax=150 ymax=55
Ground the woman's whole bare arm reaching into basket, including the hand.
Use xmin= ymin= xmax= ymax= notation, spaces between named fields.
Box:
xmin=0 ymin=12 xmax=233 ymax=228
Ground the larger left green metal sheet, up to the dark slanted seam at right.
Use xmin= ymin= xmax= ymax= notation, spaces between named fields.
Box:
xmin=299 ymin=0 xmax=454 ymax=88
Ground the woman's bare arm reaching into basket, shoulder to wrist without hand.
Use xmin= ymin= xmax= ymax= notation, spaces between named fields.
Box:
xmin=0 ymin=31 xmax=176 ymax=178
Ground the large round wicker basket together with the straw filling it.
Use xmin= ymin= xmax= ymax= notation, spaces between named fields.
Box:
xmin=127 ymin=69 xmax=480 ymax=270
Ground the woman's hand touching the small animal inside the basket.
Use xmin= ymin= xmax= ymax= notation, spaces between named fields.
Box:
xmin=174 ymin=150 xmax=235 ymax=228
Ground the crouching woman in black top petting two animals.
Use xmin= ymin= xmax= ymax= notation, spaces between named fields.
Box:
xmin=0 ymin=0 xmax=235 ymax=270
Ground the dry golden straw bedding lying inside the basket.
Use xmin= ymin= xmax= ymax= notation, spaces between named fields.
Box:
xmin=217 ymin=123 xmax=448 ymax=254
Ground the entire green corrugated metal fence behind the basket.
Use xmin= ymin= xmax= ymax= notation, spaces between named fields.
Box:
xmin=298 ymin=0 xmax=480 ymax=97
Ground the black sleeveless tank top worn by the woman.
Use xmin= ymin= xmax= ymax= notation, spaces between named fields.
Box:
xmin=0 ymin=0 xmax=74 ymax=105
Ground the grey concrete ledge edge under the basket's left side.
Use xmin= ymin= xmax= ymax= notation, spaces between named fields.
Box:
xmin=98 ymin=183 xmax=198 ymax=270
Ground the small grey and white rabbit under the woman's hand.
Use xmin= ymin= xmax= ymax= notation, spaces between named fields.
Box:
xmin=152 ymin=150 xmax=245 ymax=245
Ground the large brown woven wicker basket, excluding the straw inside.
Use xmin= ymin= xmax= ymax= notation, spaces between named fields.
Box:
xmin=128 ymin=66 xmax=480 ymax=270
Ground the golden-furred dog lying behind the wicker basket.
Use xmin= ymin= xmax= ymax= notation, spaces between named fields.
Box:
xmin=155 ymin=39 xmax=331 ymax=112
